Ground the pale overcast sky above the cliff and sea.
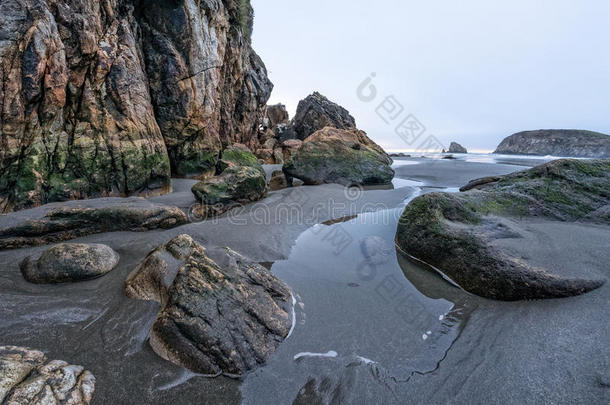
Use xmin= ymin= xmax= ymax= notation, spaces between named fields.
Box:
xmin=252 ymin=0 xmax=610 ymax=150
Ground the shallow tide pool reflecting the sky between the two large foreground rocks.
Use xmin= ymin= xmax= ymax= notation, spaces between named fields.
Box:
xmin=241 ymin=205 xmax=474 ymax=404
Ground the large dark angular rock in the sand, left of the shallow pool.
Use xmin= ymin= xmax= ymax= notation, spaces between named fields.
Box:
xmin=125 ymin=235 xmax=292 ymax=375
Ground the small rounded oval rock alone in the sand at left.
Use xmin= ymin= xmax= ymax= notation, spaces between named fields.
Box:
xmin=21 ymin=243 xmax=119 ymax=284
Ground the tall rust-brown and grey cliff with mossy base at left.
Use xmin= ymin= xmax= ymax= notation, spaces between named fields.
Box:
xmin=0 ymin=0 xmax=272 ymax=211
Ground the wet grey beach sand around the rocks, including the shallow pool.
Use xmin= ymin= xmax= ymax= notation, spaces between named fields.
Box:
xmin=0 ymin=159 xmax=610 ymax=404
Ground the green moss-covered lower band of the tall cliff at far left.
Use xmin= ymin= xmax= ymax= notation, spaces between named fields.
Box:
xmin=0 ymin=136 xmax=171 ymax=210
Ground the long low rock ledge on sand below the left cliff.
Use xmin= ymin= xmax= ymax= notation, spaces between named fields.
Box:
xmin=0 ymin=197 xmax=187 ymax=249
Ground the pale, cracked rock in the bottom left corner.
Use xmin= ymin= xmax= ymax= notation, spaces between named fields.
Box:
xmin=0 ymin=346 xmax=95 ymax=405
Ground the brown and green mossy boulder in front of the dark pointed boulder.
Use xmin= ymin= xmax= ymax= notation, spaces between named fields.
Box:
xmin=283 ymin=127 xmax=394 ymax=185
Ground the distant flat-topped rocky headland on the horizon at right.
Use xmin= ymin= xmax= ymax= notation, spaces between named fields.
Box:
xmin=494 ymin=129 xmax=610 ymax=158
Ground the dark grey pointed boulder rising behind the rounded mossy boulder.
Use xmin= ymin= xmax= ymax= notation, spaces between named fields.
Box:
xmin=292 ymin=92 xmax=356 ymax=140
